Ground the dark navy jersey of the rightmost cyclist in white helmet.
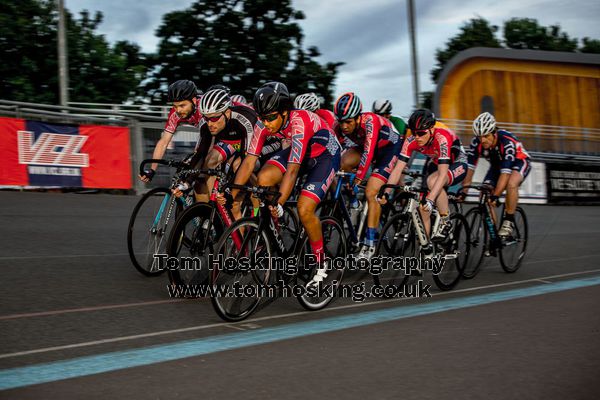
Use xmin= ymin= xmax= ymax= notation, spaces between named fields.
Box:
xmin=467 ymin=130 xmax=529 ymax=174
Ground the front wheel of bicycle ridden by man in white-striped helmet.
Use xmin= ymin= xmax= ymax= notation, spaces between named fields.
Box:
xmin=167 ymin=203 xmax=223 ymax=285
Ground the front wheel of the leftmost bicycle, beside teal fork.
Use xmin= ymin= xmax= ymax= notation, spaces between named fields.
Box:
xmin=127 ymin=188 xmax=183 ymax=276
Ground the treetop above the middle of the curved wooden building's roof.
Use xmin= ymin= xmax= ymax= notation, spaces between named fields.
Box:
xmin=504 ymin=18 xmax=577 ymax=52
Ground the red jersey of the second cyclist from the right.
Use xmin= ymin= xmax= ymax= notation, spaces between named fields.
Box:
xmin=400 ymin=128 xmax=466 ymax=165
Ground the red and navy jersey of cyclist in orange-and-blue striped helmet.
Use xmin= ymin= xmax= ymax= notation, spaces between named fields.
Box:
xmin=336 ymin=112 xmax=401 ymax=180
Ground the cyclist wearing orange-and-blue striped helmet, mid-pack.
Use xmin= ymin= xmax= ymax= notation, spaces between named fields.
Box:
xmin=334 ymin=92 xmax=402 ymax=259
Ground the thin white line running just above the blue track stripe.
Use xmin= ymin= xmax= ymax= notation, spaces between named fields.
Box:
xmin=0 ymin=269 xmax=600 ymax=359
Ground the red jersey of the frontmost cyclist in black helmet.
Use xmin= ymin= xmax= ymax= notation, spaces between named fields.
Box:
xmin=248 ymin=110 xmax=339 ymax=164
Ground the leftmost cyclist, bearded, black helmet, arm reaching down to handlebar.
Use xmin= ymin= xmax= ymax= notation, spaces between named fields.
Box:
xmin=138 ymin=80 xmax=202 ymax=182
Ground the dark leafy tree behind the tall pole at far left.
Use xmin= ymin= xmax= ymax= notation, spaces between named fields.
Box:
xmin=0 ymin=0 xmax=147 ymax=103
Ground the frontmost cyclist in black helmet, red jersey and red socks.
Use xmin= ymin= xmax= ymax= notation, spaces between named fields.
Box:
xmin=231 ymin=82 xmax=341 ymax=284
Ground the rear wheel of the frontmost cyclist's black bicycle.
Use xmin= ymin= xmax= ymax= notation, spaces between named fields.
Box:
xmin=297 ymin=217 xmax=347 ymax=311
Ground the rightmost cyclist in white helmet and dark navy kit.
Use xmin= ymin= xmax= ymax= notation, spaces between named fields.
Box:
xmin=462 ymin=112 xmax=531 ymax=237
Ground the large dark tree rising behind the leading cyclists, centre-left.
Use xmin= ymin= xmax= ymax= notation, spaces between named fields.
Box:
xmin=146 ymin=0 xmax=341 ymax=107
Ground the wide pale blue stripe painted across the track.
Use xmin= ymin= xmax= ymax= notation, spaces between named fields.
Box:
xmin=0 ymin=276 xmax=600 ymax=390
